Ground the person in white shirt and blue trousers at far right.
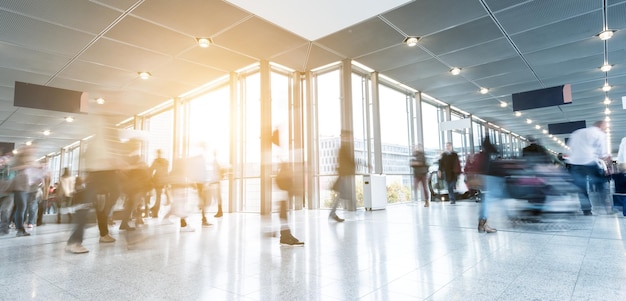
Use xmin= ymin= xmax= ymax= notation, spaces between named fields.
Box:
xmin=567 ymin=120 xmax=611 ymax=215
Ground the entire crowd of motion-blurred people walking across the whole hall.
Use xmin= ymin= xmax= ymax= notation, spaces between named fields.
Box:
xmin=0 ymin=121 xmax=626 ymax=253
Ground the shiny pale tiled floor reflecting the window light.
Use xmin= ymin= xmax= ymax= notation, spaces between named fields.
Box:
xmin=0 ymin=197 xmax=626 ymax=301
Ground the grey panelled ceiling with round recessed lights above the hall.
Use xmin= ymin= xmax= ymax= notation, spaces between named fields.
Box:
xmin=0 ymin=0 xmax=626 ymax=158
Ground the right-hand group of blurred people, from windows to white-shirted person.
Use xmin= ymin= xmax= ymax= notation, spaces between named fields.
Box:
xmin=410 ymin=120 xmax=626 ymax=233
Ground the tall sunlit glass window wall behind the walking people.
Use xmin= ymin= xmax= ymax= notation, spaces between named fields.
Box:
xmin=40 ymin=59 xmax=523 ymax=213
